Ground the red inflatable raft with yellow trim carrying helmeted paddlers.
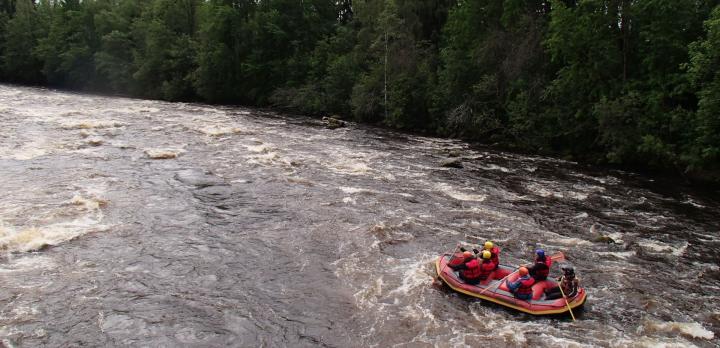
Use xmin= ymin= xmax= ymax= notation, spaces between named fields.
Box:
xmin=435 ymin=254 xmax=587 ymax=315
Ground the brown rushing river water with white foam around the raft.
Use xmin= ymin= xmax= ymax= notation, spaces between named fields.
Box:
xmin=0 ymin=86 xmax=720 ymax=347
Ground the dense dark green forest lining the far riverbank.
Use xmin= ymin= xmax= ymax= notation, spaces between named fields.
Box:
xmin=0 ymin=0 xmax=720 ymax=183
